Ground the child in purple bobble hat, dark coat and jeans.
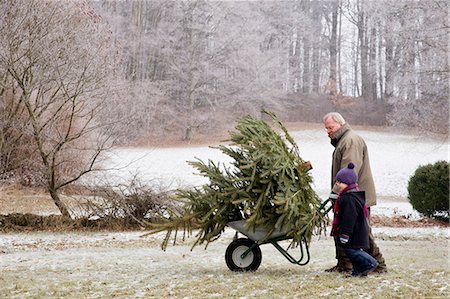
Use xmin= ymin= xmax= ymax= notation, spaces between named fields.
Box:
xmin=331 ymin=162 xmax=378 ymax=276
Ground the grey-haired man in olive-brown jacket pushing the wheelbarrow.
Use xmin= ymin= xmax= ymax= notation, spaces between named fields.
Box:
xmin=323 ymin=112 xmax=387 ymax=273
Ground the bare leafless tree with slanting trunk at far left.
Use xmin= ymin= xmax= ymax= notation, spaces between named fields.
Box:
xmin=0 ymin=0 xmax=119 ymax=217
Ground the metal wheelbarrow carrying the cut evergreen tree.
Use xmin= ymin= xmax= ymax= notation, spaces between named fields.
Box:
xmin=225 ymin=199 xmax=332 ymax=272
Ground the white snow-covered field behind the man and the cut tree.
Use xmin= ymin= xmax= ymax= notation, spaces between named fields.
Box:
xmin=103 ymin=128 xmax=449 ymax=218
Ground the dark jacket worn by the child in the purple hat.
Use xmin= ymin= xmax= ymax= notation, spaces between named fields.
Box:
xmin=334 ymin=191 xmax=369 ymax=249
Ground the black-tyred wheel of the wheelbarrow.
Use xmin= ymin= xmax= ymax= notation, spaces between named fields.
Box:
xmin=225 ymin=238 xmax=262 ymax=272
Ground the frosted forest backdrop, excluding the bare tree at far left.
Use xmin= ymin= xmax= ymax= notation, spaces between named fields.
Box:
xmin=94 ymin=0 xmax=450 ymax=141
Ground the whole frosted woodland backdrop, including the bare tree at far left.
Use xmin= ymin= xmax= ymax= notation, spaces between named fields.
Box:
xmin=0 ymin=0 xmax=450 ymax=206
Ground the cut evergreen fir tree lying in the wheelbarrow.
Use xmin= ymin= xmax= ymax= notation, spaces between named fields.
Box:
xmin=150 ymin=110 xmax=327 ymax=249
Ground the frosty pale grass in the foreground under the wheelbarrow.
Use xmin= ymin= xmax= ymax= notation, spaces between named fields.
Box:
xmin=0 ymin=234 xmax=449 ymax=298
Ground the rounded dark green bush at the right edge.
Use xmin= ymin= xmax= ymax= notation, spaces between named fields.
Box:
xmin=408 ymin=161 xmax=449 ymax=219
